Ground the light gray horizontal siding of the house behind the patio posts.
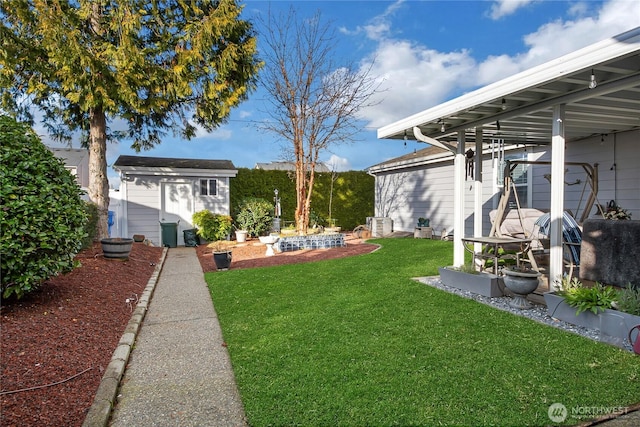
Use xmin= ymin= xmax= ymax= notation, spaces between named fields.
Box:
xmin=376 ymin=131 xmax=640 ymax=236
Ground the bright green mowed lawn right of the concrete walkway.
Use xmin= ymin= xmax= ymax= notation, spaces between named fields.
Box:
xmin=206 ymin=239 xmax=640 ymax=426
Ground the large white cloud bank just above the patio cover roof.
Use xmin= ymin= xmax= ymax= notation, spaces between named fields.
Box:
xmin=361 ymin=0 xmax=640 ymax=128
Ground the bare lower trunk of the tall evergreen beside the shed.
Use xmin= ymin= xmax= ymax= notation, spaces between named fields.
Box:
xmin=89 ymin=108 xmax=109 ymax=240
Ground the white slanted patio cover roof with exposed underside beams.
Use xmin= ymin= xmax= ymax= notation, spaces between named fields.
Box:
xmin=378 ymin=27 xmax=640 ymax=148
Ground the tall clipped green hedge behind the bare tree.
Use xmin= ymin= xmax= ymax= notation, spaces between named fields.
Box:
xmin=231 ymin=168 xmax=374 ymax=230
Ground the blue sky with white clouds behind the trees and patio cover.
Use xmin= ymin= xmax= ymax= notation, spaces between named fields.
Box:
xmin=45 ymin=0 xmax=640 ymax=187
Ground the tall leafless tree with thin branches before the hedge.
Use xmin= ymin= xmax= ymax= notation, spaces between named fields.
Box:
xmin=259 ymin=8 xmax=377 ymax=234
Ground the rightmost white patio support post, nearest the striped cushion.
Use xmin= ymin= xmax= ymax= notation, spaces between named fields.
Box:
xmin=549 ymin=104 xmax=565 ymax=290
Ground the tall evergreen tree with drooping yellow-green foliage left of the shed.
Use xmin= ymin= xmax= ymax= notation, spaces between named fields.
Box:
xmin=0 ymin=0 xmax=260 ymax=237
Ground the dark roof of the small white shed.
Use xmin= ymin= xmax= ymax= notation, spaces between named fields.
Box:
xmin=113 ymin=156 xmax=238 ymax=176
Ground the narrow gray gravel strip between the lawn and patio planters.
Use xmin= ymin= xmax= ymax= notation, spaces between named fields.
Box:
xmin=416 ymin=276 xmax=632 ymax=351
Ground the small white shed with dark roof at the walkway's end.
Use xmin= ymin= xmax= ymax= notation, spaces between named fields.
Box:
xmin=113 ymin=156 xmax=238 ymax=246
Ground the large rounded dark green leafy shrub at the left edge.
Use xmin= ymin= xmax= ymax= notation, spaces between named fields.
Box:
xmin=0 ymin=115 xmax=87 ymax=298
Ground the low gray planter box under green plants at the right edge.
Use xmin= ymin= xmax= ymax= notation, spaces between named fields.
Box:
xmin=544 ymin=292 xmax=640 ymax=343
